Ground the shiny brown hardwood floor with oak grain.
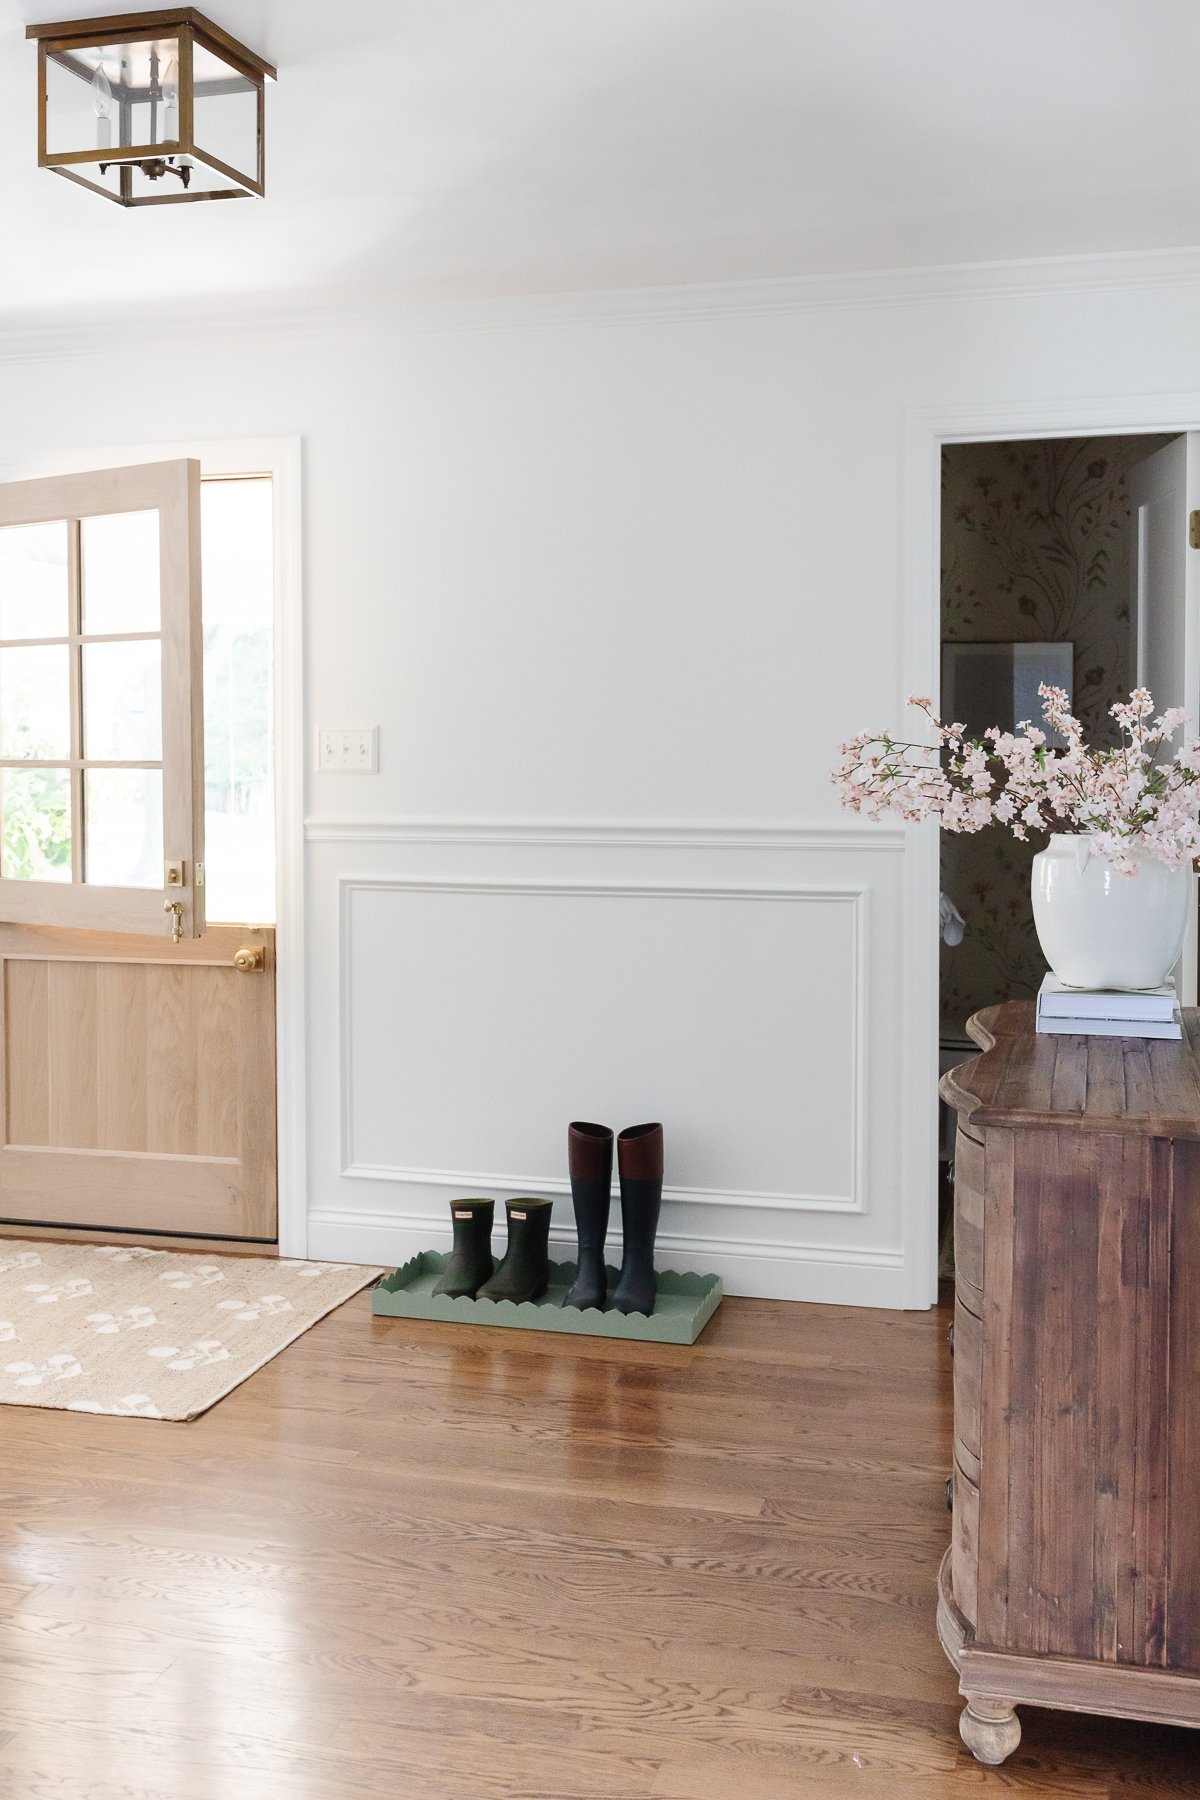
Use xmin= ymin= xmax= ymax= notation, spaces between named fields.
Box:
xmin=0 ymin=1294 xmax=1200 ymax=1800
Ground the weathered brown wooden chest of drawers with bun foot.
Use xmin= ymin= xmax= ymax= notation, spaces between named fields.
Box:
xmin=937 ymin=1003 xmax=1200 ymax=1764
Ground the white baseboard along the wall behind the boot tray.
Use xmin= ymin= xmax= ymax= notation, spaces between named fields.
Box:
xmin=308 ymin=1206 xmax=910 ymax=1309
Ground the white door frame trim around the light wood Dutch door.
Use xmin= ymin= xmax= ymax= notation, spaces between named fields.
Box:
xmin=0 ymin=436 xmax=308 ymax=1256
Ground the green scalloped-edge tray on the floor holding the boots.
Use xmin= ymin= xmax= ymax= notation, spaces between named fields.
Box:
xmin=371 ymin=1249 xmax=721 ymax=1345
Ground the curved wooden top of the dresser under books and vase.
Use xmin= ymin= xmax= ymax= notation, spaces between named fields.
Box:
xmin=941 ymin=1001 xmax=1200 ymax=1139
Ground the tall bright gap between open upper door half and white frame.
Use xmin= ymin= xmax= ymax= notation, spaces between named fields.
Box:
xmin=200 ymin=477 xmax=275 ymax=925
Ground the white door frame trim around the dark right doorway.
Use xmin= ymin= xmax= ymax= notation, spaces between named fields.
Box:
xmin=900 ymin=391 xmax=1200 ymax=1307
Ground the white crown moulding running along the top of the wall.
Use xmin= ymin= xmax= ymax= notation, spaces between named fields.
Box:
xmin=0 ymin=247 xmax=1200 ymax=362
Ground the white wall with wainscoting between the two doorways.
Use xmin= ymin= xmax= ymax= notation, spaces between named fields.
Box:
xmin=0 ymin=259 xmax=1200 ymax=1305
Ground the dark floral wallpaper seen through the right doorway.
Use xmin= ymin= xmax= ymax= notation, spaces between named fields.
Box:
xmin=941 ymin=437 xmax=1169 ymax=1037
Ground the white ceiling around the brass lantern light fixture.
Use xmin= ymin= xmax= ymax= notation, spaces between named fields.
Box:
xmin=0 ymin=0 xmax=1200 ymax=324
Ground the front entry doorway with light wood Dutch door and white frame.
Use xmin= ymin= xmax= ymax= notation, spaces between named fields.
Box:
xmin=0 ymin=445 xmax=295 ymax=1255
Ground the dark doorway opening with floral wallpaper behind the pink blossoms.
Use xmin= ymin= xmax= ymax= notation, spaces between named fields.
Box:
xmin=937 ymin=432 xmax=1180 ymax=1273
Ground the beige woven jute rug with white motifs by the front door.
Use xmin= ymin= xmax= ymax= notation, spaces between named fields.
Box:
xmin=0 ymin=1238 xmax=381 ymax=1418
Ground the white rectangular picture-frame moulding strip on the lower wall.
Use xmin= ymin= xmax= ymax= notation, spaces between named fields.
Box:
xmin=338 ymin=875 xmax=871 ymax=1213
